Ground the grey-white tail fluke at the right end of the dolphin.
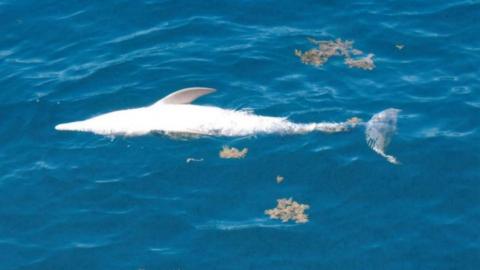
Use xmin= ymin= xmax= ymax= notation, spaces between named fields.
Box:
xmin=365 ymin=108 xmax=400 ymax=164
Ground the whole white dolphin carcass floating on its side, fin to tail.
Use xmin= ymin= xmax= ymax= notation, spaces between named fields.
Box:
xmin=55 ymin=87 xmax=400 ymax=163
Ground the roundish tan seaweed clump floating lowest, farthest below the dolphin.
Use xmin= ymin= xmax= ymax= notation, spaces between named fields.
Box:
xmin=265 ymin=198 xmax=310 ymax=223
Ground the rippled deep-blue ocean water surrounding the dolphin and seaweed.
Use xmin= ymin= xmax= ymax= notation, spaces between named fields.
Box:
xmin=0 ymin=0 xmax=480 ymax=270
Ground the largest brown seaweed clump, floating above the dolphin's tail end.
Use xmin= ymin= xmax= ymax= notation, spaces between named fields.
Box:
xmin=295 ymin=38 xmax=375 ymax=70
